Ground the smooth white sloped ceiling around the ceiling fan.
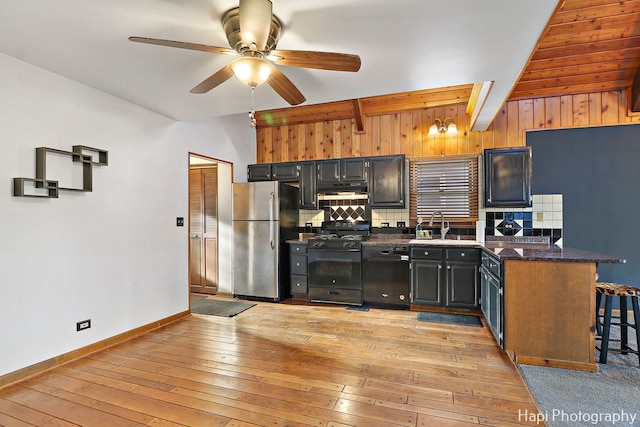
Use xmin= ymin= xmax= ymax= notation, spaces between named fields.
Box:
xmin=0 ymin=0 xmax=558 ymax=130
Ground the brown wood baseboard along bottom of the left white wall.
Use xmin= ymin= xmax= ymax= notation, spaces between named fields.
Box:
xmin=0 ymin=310 xmax=191 ymax=389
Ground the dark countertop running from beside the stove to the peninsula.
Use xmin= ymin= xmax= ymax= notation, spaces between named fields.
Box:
xmin=287 ymin=233 xmax=626 ymax=264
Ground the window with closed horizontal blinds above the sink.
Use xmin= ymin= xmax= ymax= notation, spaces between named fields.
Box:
xmin=409 ymin=155 xmax=478 ymax=226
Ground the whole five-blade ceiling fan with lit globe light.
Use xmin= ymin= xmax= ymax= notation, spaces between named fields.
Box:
xmin=129 ymin=0 xmax=360 ymax=105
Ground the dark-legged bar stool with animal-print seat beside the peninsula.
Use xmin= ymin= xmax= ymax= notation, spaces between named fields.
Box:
xmin=596 ymin=282 xmax=640 ymax=363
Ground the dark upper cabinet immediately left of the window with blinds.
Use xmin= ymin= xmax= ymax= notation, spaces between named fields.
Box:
xmin=367 ymin=155 xmax=406 ymax=208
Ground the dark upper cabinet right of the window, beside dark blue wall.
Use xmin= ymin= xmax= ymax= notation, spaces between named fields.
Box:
xmin=484 ymin=147 xmax=532 ymax=207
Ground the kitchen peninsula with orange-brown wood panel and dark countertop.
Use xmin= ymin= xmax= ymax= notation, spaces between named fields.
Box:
xmin=290 ymin=233 xmax=625 ymax=371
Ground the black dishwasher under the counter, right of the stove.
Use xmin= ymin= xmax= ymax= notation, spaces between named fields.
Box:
xmin=362 ymin=245 xmax=411 ymax=308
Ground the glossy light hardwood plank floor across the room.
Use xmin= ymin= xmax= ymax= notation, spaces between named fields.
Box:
xmin=0 ymin=297 xmax=537 ymax=427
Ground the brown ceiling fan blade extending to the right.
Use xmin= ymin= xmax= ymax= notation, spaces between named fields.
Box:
xmin=269 ymin=49 xmax=360 ymax=72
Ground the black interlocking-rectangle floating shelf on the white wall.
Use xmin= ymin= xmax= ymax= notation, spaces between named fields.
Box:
xmin=13 ymin=145 xmax=109 ymax=198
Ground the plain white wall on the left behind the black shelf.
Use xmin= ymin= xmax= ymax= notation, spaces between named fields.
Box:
xmin=0 ymin=55 xmax=255 ymax=375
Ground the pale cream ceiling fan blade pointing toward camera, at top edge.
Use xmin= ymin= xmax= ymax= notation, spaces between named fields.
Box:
xmin=238 ymin=0 xmax=272 ymax=50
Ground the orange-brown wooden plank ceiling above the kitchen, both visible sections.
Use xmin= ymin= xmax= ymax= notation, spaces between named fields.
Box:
xmin=256 ymin=0 xmax=640 ymax=128
